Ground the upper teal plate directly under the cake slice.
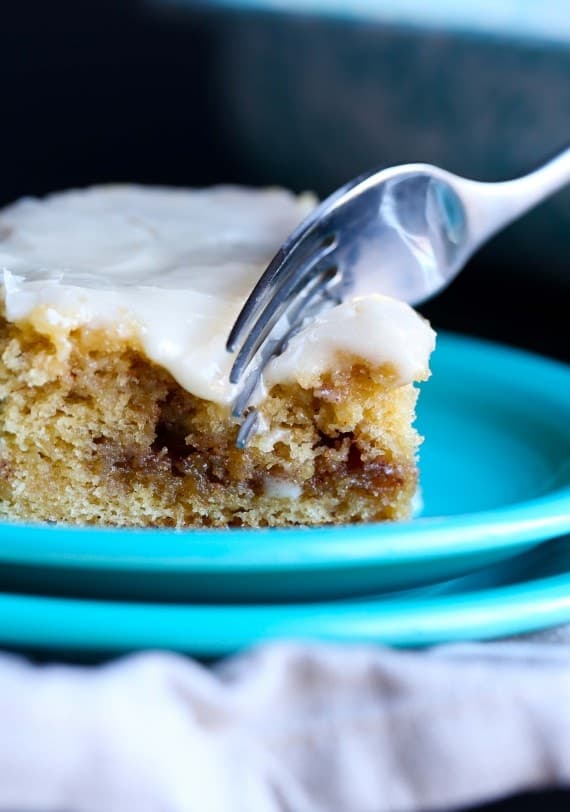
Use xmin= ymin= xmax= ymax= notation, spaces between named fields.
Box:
xmin=0 ymin=335 xmax=570 ymax=602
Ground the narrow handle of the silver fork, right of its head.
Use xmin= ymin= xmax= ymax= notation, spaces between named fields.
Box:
xmin=465 ymin=147 xmax=570 ymax=245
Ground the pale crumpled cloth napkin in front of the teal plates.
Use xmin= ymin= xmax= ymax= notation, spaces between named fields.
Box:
xmin=0 ymin=627 xmax=570 ymax=812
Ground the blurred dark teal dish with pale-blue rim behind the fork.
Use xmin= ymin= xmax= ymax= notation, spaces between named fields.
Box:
xmin=152 ymin=0 xmax=570 ymax=286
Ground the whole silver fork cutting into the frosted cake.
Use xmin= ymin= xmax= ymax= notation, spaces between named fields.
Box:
xmin=227 ymin=148 xmax=570 ymax=447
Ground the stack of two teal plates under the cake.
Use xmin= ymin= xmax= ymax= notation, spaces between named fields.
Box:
xmin=0 ymin=335 xmax=570 ymax=656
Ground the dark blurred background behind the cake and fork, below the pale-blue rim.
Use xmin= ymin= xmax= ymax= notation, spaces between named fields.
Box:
xmin=0 ymin=0 xmax=570 ymax=360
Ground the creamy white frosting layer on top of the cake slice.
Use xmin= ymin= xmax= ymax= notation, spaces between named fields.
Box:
xmin=0 ymin=186 xmax=434 ymax=403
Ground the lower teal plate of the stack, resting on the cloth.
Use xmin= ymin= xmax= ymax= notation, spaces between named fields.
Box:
xmin=0 ymin=538 xmax=570 ymax=657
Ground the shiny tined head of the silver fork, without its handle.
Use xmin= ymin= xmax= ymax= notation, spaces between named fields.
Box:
xmin=227 ymin=165 xmax=465 ymax=445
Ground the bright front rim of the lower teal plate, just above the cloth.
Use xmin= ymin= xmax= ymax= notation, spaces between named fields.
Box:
xmin=0 ymin=572 xmax=570 ymax=656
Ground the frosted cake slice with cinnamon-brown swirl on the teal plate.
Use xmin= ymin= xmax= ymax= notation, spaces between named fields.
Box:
xmin=0 ymin=186 xmax=434 ymax=527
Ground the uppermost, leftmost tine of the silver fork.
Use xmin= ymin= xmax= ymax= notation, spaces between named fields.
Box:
xmin=226 ymin=221 xmax=324 ymax=352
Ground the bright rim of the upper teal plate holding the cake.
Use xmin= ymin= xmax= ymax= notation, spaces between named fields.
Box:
xmin=0 ymin=331 xmax=570 ymax=574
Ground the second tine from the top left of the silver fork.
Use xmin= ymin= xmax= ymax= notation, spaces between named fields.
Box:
xmin=230 ymin=243 xmax=336 ymax=383
